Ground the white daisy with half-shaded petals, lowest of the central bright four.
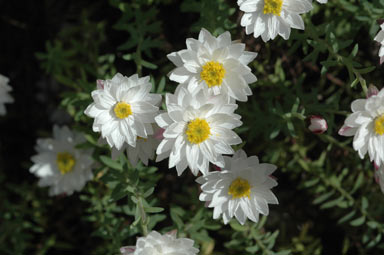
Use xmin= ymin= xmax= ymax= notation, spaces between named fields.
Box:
xmin=196 ymin=150 xmax=278 ymax=225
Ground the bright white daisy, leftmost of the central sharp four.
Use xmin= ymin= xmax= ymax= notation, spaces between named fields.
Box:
xmin=84 ymin=73 xmax=161 ymax=150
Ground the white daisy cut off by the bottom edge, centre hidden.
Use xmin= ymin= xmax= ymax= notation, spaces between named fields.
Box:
xmin=120 ymin=231 xmax=199 ymax=255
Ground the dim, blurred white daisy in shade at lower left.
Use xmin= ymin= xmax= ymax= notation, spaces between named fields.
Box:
xmin=29 ymin=126 xmax=93 ymax=196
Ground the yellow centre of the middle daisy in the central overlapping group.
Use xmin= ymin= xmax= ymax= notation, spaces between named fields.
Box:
xmin=185 ymin=118 xmax=211 ymax=144
